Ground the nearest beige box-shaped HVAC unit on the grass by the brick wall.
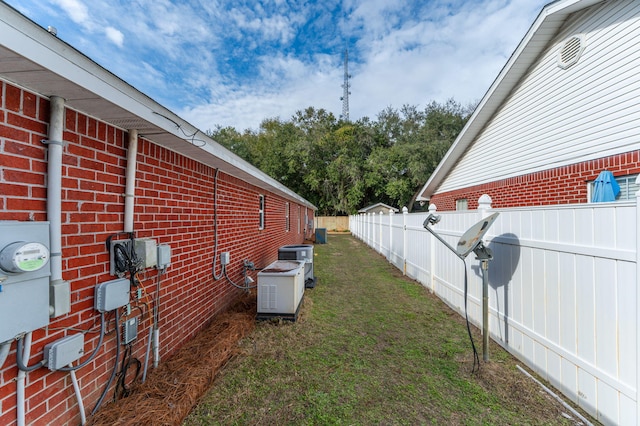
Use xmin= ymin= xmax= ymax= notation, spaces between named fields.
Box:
xmin=256 ymin=260 xmax=305 ymax=321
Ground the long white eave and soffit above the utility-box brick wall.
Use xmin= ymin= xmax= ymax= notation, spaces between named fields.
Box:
xmin=0 ymin=2 xmax=316 ymax=210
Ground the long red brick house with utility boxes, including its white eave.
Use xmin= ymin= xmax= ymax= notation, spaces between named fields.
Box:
xmin=0 ymin=3 xmax=316 ymax=425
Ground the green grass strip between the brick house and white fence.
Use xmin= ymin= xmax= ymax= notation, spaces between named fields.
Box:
xmin=184 ymin=235 xmax=592 ymax=425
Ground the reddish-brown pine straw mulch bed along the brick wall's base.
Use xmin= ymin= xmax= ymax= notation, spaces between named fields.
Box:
xmin=89 ymin=293 xmax=256 ymax=426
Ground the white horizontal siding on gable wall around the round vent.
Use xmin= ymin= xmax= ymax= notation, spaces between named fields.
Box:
xmin=437 ymin=0 xmax=640 ymax=193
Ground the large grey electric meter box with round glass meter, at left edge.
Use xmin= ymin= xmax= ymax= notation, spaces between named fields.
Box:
xmin=0 ymin=221 xmax=51 ymax=343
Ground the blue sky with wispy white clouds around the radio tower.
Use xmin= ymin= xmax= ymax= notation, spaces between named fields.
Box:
xmin=5 ymin=0 xmax=548 ymax=131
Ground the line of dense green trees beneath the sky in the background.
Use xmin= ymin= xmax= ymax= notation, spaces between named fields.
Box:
xmin=207 ymin=99 xmax=473 ymax=216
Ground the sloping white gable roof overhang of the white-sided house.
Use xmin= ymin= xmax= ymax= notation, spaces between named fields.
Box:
xmin=417 ymin=0 xmax=606 ymax=201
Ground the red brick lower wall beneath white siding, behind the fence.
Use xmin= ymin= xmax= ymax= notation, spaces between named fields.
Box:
xmin=430 ymin=151 xmax=640 ymax=211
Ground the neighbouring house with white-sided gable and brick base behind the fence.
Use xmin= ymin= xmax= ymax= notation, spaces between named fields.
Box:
xmin=418 ymin=0 xmax=640 ymax=210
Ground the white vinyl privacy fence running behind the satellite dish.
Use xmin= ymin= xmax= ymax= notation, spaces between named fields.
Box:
xmin=349 ymin=195 xmax=640 ymax=425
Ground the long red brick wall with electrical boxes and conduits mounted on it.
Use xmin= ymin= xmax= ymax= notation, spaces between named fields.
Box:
xmin=0 ymin=82 xmax=313 ymax=425
